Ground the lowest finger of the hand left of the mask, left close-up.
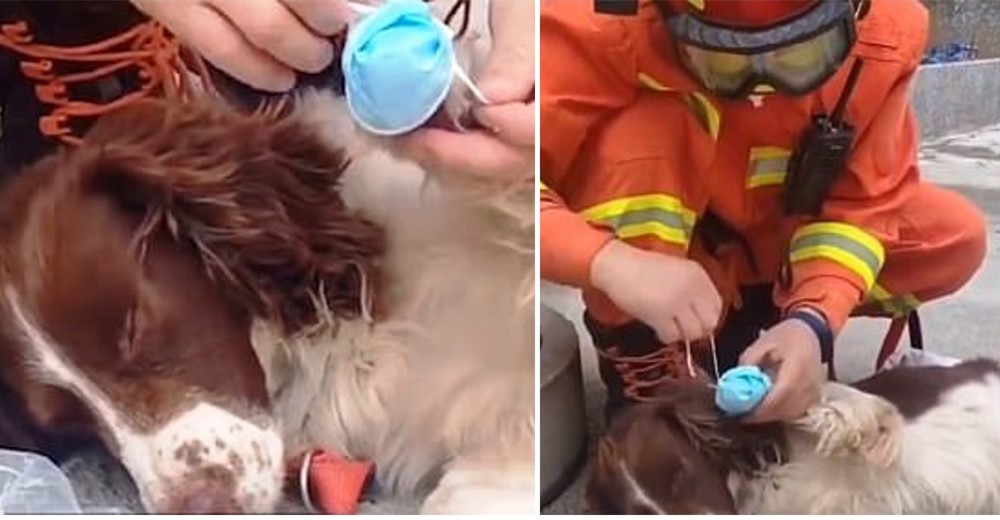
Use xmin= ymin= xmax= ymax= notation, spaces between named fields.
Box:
xmin=147 ymin=2 xmax=295 ymax=92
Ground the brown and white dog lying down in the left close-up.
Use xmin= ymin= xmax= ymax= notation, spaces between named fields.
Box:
xmin=0 ymin=48 xmax=537 ymax=513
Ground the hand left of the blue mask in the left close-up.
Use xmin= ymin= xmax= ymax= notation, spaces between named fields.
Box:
xmin=131 ymin=0 xmax=354 ymax=92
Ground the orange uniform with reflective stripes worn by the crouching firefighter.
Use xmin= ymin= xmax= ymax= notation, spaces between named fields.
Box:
xmin=540 ymin=0 xmax=986 ymax=340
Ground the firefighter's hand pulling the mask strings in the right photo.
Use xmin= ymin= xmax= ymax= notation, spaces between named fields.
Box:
xmin=590 ymin=240 xmax=722 ymax=344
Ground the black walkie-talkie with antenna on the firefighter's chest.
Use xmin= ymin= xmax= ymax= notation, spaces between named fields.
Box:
xmin=785 ymin=58 xmax=864 ymax=216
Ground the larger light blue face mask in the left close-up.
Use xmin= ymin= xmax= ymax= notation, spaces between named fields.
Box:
xmin=341 ymin=0 xmax=485 ymax=136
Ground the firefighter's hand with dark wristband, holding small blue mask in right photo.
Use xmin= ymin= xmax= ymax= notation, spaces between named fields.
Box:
xmin=740 ymin=311 xmax=826 ymax=423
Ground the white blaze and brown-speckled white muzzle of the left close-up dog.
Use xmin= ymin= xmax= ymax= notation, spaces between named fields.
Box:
xmin=4 ymin=287 xmax=284 ymax=513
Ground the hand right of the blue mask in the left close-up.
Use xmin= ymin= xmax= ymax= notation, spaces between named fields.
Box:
xmin=400 ymin=0 xmax=535 ymax=177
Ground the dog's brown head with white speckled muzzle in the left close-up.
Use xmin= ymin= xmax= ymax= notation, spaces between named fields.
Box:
xmin=0 ymin=97 xmax=381 ymax=512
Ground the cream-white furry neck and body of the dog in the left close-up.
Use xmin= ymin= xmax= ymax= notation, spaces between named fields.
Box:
xmin=247 ymin=93 xmax=538 ymax=514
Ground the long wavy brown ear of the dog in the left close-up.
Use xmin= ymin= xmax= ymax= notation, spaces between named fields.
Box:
xmin=77 ymin=97 xmax=383 ymax=332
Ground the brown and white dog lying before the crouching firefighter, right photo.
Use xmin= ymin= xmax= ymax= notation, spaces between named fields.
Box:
xmin=588 ymin=359 xmax=1000 ymax=514
